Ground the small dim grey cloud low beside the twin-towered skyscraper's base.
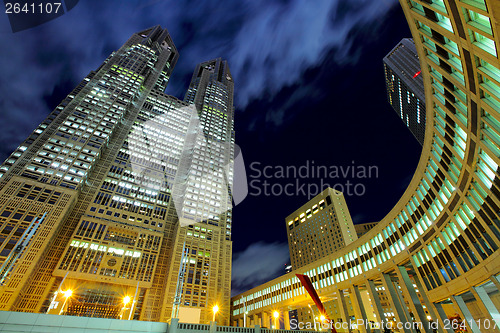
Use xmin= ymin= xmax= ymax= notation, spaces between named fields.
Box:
xmin=231 ymin=242 xmax=290 ymax=295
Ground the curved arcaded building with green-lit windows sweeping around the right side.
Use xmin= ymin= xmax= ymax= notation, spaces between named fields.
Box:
xmin=231 ymin=0 xmax=500 ymax=332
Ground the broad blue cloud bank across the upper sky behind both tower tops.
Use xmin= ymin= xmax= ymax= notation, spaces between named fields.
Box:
xmin=0 ymin=0 xmax=397 ymax=160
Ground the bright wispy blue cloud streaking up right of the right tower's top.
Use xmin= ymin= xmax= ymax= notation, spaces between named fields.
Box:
xmin=230 ymin=0 xmax=397 ymax=105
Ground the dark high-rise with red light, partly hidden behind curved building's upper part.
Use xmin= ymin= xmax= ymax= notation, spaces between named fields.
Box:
xmin=383 ymin=38 xmax=425 ymax=145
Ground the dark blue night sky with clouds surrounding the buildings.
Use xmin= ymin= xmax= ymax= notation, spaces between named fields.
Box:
xmin=0 ymin=0 xmax=421 ymax=294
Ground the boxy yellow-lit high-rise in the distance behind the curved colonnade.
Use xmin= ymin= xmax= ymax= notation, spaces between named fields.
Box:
xmin=286 ymin=188 xmax=358 ymax=270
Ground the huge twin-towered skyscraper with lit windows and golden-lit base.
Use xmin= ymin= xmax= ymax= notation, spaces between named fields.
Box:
xmin=0 ymin=26 xmax=234 ymax=323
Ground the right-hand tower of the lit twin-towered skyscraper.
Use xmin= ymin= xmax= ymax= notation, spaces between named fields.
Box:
xmin=164 ymin=59 xmax=235 ymax=323
